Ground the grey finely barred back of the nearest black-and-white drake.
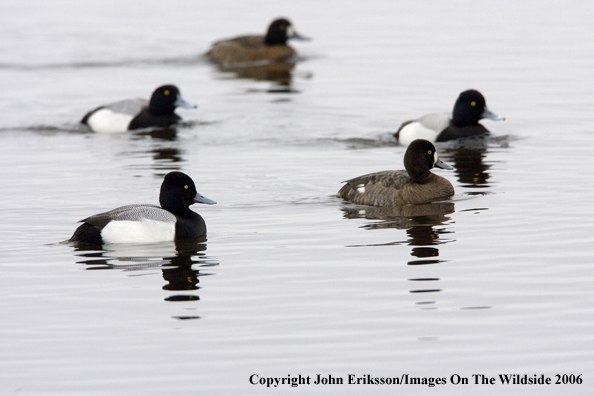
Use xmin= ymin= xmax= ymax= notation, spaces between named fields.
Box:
xmin=81 ymin=204 xmax=177 ymax=229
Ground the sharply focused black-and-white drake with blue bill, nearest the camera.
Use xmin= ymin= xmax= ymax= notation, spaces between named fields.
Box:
xmin=69 ymin=172 xmax=216 ymax=245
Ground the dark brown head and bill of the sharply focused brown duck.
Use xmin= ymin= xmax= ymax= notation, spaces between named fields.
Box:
xmin=404 ymin=139 xmax=452 ymax=184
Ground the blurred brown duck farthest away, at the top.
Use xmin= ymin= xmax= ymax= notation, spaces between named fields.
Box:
xmin=206 ymin=18 xmax=309 ymax=66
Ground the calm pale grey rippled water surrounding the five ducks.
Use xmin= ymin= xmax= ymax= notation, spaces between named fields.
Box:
xmin=0 ymin=0 xmax=594 ymax=395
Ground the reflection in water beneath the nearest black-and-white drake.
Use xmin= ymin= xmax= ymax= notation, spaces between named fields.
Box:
xmin=70 ymin=238 xmax=218 ymax=319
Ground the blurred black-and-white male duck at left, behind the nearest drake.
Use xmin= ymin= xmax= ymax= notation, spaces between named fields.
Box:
xmin=80 ymin=85 xmax=198 ymax=133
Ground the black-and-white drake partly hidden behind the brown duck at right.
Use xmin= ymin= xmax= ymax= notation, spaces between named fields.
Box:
xmin=394 ymin=89 xmax=505 ymax=146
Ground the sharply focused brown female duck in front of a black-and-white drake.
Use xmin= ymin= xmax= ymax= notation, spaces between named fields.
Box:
xmin=337 ymin=139 xmax=454 ymax=206
